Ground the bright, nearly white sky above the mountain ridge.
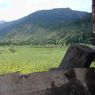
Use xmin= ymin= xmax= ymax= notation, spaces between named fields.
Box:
xmin=0 ymin=0 xmax=92 ymax=21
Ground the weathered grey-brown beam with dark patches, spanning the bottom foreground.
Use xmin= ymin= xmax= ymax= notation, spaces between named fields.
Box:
xmin=0 ymin=68 xmax=95 ymax=95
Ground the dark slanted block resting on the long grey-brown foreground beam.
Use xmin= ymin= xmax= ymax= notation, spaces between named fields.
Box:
xmin=50 ymin=44 xmax=95 ymax=71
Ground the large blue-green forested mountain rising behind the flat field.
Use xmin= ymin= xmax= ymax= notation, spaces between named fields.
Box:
xmin=0 ymin=8 xmax=92 ymax=44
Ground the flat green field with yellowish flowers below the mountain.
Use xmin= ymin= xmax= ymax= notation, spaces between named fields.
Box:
xmin=0 ymin=46 xmax=67 ymax=74
